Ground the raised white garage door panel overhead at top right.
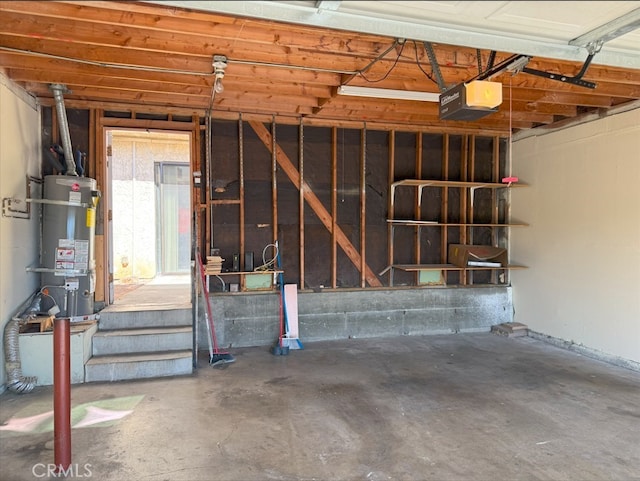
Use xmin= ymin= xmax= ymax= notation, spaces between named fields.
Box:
xmin=151 ymin=0 xmax=640 ymax=68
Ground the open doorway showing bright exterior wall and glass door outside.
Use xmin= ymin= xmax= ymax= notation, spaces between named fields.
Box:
xmin=106 ymin=129 xmax=191 ymax=302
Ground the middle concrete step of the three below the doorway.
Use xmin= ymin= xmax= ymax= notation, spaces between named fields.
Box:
xmin=92 ymin=326 xmax=193 ymax=356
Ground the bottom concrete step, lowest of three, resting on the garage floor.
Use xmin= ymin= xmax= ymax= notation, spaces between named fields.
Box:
xmin=84 ymin=350 xmax=193 ymax=382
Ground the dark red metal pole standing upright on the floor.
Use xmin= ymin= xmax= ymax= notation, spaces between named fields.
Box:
xmin=53 ymin=317 xmax=71 ymax=471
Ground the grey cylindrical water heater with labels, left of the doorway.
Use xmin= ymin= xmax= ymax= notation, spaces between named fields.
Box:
xmin=38 ymin=175 xmax=100 ymax=317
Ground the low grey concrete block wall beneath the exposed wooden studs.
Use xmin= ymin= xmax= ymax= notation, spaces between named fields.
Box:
xmin=198 ymin=286 xmax=513 ymax=349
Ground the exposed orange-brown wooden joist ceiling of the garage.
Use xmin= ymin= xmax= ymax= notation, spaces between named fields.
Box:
xmin=0 ymin=0 xmax=640 ymax=134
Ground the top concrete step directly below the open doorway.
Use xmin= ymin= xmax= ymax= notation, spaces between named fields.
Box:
xmin=99 ymin=308 xmax=192 ymax=330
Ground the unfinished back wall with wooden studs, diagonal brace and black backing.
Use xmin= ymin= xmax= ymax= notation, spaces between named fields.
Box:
xmin=203 ymin=119 xmax=509 ymax=290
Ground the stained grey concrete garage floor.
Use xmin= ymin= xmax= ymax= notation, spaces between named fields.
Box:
xmin=0 ymin=333 xmax=640 ymax=481
